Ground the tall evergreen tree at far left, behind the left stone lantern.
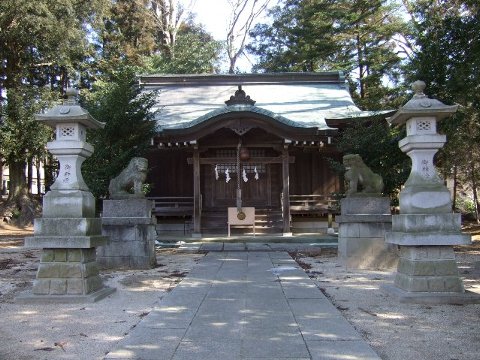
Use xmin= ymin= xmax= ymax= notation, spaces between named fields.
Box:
xmin=0 ymin=0 xmax=104 ymax=206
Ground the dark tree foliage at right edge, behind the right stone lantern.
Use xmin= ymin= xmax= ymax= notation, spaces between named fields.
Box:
xmin=405 ymin=0 xmax=480 ymax=218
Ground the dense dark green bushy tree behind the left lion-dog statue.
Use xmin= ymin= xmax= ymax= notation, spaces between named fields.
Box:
xmin=82 ymin=66 xmax=156 ymax=198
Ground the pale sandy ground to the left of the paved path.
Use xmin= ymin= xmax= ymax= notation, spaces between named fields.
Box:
xmin=0 ymin=235 xmax=204 ymax=360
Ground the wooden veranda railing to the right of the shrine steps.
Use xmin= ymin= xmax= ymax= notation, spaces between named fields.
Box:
xmin=290 ymin=195 xmax=338 ymax=216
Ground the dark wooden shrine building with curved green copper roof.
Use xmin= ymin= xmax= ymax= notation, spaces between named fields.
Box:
xmin=139 ymin=72 xmax=386 ymax=236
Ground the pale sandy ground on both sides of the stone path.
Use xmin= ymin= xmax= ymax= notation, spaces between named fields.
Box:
xmin=0 ymin=224 xmax=480 ymax=360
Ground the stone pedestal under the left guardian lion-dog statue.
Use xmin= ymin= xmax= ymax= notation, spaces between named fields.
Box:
xmin=97 ymin=198 xmax=157 ymax=269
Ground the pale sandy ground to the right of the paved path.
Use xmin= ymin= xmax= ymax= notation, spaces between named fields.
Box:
xmin=297 ymin=251 xmax=480 ymax=360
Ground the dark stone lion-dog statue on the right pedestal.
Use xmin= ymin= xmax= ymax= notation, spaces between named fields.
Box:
xmin=343 ymin=154 xmax=383 ymax=196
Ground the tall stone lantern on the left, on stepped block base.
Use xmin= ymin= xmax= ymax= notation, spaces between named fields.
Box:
xmin=17 ymin=89 xmax=115 ymax=302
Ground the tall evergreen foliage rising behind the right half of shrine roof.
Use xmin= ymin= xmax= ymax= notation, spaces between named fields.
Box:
xmin=247 ymin=0 xmax=405 ymax=110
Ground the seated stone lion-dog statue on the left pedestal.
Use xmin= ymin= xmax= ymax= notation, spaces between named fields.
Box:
xmin=108 ymin=157 xmax=148 ymax=199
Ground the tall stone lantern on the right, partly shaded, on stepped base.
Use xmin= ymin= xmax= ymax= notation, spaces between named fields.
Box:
xmin=385 ymin=81 xmax=479 ymax=304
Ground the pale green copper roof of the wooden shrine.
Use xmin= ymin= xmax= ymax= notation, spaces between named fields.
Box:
xmin=139 ymin=72 xmax=384 ymax=130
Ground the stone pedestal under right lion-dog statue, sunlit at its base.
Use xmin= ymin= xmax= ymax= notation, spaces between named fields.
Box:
xmin=335 ymin=196 xmax=398 ymax=270
